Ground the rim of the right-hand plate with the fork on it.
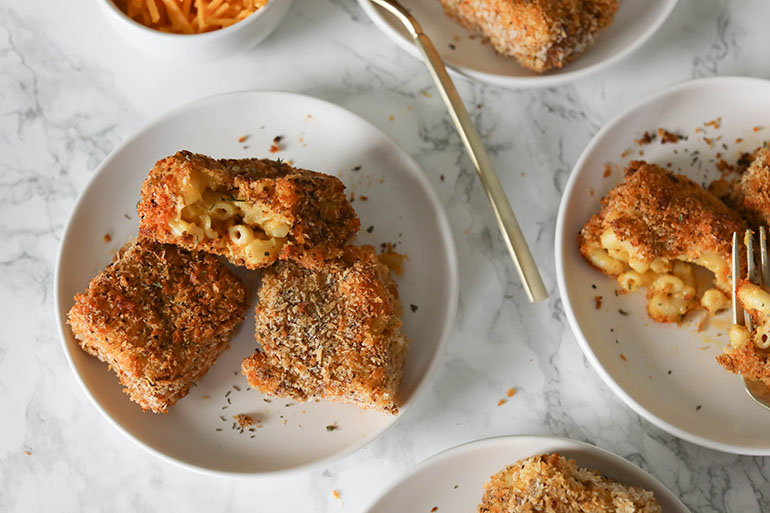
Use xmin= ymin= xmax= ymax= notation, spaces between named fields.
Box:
xmin=554 ymin=75 xmax=770 ymax=456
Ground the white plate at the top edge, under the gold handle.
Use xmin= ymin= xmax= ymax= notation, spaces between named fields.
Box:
xmin=358 ymin=0 xmax=676 ymax=88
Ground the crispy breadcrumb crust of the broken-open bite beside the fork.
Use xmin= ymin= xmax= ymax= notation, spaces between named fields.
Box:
xmin=578 ymin=161 xmax=745 ymax=292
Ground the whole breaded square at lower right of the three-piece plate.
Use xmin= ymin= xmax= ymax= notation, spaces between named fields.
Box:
xmin=242 ymin=246 xmax=407 ymax=414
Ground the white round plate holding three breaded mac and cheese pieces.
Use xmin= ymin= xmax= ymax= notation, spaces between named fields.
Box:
xmin=54 ymin=91 xmax=458 ymax=475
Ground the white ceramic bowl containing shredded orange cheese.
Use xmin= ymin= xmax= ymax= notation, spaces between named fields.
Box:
xmin=97 ymin=0 xmax=294 ymax=62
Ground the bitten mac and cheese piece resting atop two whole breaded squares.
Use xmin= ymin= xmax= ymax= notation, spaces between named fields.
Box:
xmin=137 ymin=151 xmax=360 ymax=269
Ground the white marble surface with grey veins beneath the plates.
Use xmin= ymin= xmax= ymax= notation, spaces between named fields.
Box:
xmin=0 ymin=0 xmax=770 ymax=513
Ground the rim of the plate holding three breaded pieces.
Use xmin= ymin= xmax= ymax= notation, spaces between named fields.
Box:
xmin=53 ymin=89 xmax=460 ymax=479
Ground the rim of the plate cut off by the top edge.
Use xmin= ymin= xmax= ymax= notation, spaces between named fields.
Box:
xmin=358 ymin=0 xmax=679 ymax=89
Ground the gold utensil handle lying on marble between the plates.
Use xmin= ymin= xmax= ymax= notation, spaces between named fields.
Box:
xmin=372 ymin=0 xmax=548 ymax=303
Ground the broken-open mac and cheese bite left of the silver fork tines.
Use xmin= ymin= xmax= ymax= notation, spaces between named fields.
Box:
xmin=578 ymin=161 xmax=745 ymax=322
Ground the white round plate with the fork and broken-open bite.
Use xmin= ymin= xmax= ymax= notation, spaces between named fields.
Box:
xmin=556 ymin=77 xmax=770 ymax=455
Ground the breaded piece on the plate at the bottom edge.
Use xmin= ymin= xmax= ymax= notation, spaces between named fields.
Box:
xmin=478 ymin=453 xmax=661 ymax=513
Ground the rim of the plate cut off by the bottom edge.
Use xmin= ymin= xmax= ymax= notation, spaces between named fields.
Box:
xmin=362 ymin=433 xmax=690 ymax=513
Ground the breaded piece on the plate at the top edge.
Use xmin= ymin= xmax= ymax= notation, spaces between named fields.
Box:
xmin=441 ymin=0 xmax=618 ymax=73
